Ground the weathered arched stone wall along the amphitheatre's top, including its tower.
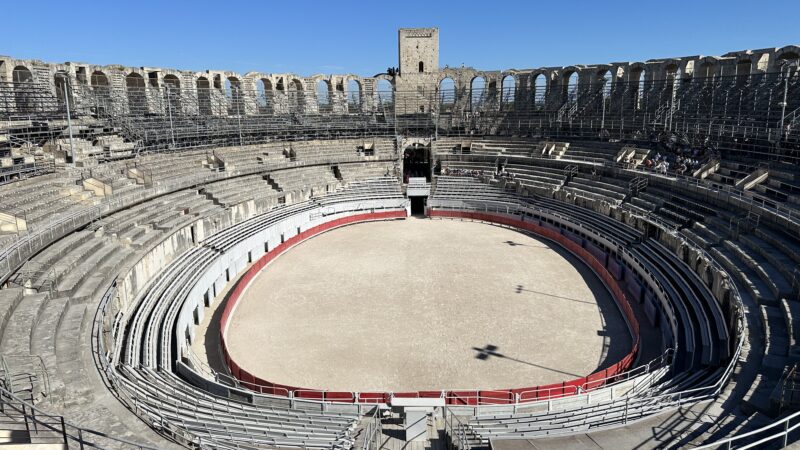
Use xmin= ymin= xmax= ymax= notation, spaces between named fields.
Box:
xmin=0 ymin=42 xmax=800 ymax=103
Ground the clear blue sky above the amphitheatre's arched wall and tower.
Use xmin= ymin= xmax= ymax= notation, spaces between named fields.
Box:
xmin=6 ymin=0 xmax=800 ymax=76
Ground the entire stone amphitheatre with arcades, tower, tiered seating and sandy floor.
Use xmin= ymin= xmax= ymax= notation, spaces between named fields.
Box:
xmin=0 ymin=28 xmax=800 ymax=450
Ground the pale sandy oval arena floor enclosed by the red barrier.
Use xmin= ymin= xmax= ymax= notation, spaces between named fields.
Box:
xmin=227 ymin=218 xmax=631 ymax=392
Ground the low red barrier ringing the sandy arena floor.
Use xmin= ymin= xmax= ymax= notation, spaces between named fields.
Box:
xmin=220 ymin=210 xmax=639 ymax=406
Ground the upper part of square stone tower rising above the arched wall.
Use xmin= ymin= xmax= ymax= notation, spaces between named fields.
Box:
xmin=398 ymin=28 xmax=439 ymax=77
